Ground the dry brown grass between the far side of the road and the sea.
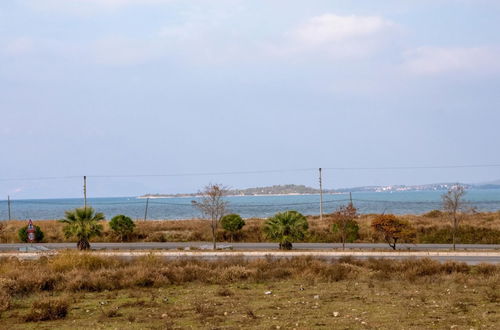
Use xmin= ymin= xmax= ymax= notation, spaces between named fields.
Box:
xmin=0 ymin=211 xmax=500 ymax=244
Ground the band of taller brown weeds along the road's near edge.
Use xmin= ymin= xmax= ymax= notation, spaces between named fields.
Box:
xmin=0 ymin=253 xmax=500 ymax=296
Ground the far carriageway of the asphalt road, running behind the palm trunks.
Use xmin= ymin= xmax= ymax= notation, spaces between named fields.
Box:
xmin=0 ymin=242 xmax=500 ymax=252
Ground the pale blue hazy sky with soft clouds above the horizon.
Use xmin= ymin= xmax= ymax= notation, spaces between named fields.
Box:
xmin=0 ymin=0 xmax=500 ymax=199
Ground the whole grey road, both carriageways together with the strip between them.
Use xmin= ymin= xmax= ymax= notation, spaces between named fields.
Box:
xmin=0 ymin=242 xmax=500 ymax=264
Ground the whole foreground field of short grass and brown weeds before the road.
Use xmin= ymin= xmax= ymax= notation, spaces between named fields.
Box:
xmin=0 ymin=253 xmax=500 ymax=329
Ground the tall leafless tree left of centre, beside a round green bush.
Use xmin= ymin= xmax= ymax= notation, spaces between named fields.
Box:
xmin=191 ymin=183 xmax=227 ymax=250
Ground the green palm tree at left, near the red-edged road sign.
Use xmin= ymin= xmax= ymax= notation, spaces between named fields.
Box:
xmin=59 ymin=207 xmax=104 ymax=250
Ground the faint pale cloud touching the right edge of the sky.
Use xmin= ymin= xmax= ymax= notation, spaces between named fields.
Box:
xmin=403 ymin=47 xmax=500 ymax=75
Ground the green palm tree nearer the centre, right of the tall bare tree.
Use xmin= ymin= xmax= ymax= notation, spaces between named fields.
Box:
xmin=264 ymin=211 xmax=309 ymax=250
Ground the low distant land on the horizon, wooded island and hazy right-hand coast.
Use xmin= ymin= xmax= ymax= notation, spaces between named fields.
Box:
xmin=138 ymin=181 xmax=500 ymax=198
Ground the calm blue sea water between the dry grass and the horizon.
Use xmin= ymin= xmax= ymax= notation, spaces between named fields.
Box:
xmin=0 ymin=189 xmax=500 ymax=220
